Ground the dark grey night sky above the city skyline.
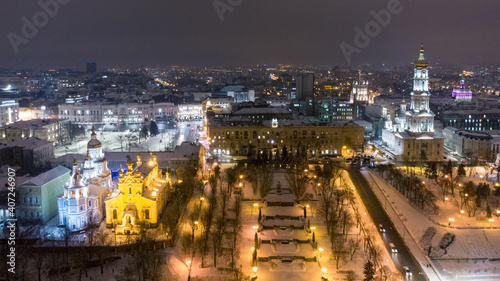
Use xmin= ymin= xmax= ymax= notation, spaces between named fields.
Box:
xmin=0 ymin=0 xmax=500 ymax=70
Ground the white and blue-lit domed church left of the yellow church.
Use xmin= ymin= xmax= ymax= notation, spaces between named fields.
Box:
xmin=57 ymin=127 xmax=114 ymax=231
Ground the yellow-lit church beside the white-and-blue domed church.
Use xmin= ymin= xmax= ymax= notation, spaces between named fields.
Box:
xmin=105 ymin=155 xmax=170 ymax=234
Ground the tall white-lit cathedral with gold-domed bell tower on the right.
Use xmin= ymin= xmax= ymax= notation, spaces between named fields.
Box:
xmin=382 ymin=45 xmax=444 ymax=161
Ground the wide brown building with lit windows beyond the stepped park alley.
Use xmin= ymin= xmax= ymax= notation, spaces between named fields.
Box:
xmin=208 ymin=119 xmax=364 ymax=156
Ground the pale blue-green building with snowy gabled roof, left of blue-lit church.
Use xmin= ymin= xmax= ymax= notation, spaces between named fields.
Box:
xmin=16 ymin=166 xmax=71 ymax=223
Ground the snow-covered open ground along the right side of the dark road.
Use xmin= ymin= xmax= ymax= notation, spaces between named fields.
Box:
xmin=362 ymin=167 xmax=500 ymax=280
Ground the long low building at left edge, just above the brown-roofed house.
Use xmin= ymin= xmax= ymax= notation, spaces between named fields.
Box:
xmin=0 ymin=119 xmax=70 ymax=145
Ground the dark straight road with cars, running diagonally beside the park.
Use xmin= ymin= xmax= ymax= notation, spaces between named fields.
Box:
xmin=347 ymin=167 xmax=427 ymax=281
